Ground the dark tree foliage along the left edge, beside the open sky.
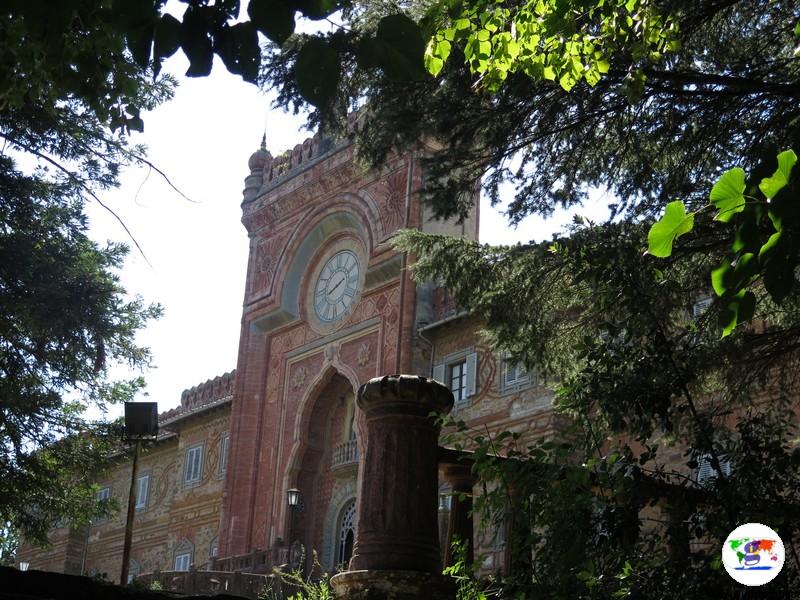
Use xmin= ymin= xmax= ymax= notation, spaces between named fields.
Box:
xmin=0 ymin=0 xmax=172 ymax=547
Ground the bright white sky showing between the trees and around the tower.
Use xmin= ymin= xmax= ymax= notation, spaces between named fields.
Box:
xmin=88 ymin=37 xmax=606 ymax=416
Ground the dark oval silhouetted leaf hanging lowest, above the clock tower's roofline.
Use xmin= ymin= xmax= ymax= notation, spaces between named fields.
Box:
xmin=294 ymin=37 xmax=340 ymax=106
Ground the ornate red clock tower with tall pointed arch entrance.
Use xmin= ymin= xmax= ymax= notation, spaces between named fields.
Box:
xmin=219 ymin=127 xmax=477 ymax=569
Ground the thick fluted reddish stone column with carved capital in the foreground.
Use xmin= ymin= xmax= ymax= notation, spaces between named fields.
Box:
xmin=331 ymin=375 xmax=453 ymax=599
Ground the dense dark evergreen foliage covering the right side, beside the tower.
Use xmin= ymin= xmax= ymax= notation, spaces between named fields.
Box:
xmin=374 ymin=2 xmax=800 ymax=598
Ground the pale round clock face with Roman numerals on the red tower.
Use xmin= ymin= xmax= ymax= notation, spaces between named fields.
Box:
xmin=314 ymin=250 xmax=360 ymax=323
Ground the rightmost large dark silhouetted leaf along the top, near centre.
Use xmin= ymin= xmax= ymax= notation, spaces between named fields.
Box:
xmin=375 ymin=14 xmax=428 ymax=81
